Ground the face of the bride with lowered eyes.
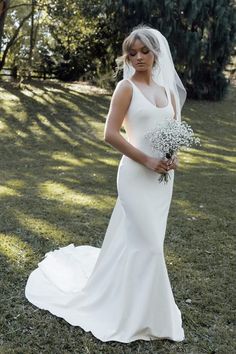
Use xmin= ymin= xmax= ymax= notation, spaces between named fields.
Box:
xmin=128 ymin=39 xmax=154 ymax=71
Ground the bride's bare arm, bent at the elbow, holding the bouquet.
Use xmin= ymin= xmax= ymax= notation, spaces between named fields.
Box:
xmin=104 ymin=80 xmax=167 ymax=173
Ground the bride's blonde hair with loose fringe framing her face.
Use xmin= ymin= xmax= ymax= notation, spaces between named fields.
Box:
xmin=115 ymin=25 xmax=160 ymax=75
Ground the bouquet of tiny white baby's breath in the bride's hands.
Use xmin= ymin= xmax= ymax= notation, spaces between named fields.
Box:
xmin=145 ymin=119 xmax=200 ymax=182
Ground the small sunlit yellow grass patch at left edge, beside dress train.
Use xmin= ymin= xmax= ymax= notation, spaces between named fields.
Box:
xmin=0 ymin=233 xmax=33 ymax=266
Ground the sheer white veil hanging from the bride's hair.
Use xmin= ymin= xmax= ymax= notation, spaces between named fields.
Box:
xmin=123 ymin=28 xmax=187 ymax=121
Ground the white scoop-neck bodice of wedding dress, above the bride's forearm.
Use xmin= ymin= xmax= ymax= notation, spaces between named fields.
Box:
xmin=124 ymin=79 xmax=175 ymax=156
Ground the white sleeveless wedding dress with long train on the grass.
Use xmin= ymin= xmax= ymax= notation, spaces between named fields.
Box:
xmin=25 ymin=80 xmax=184 ymax=343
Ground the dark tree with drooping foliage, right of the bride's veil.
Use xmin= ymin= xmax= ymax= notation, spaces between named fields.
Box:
xmin=173 ymin=0 xmax=236 ymax=100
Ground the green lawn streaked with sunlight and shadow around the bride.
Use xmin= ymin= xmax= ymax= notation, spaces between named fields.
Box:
xmin=0 ymin=81 xmax=236 ymax=354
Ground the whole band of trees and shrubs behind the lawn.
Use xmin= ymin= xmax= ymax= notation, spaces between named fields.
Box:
xmin=0 ymin=0 xmax=236 ymax=100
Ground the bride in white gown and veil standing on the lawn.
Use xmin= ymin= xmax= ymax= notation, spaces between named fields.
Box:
xmin=25 ymin=26 xmax=186 ymax=343
